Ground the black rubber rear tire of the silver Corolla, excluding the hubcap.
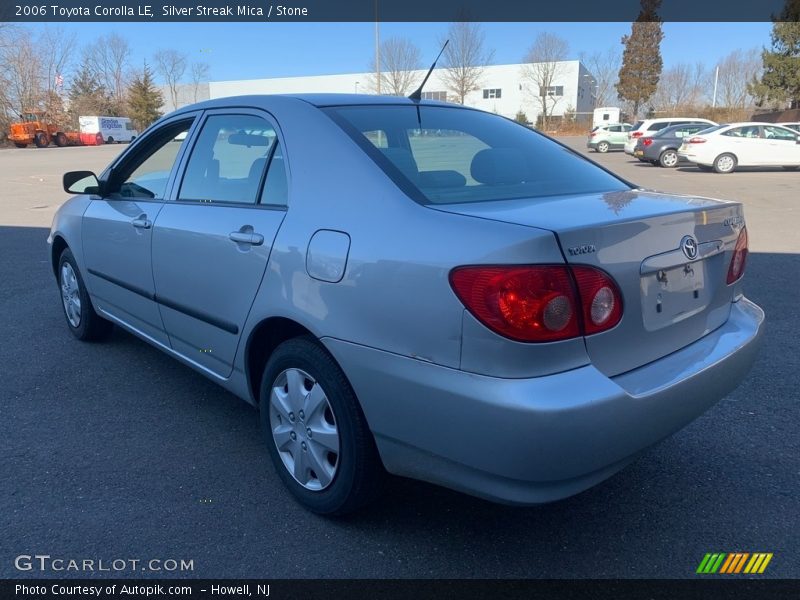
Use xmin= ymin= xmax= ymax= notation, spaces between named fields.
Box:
xmin=259 ymin=336 xmax=385 ymax=516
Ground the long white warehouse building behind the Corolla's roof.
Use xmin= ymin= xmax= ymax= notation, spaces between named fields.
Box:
xmin=188 ymin=60 xmax=595 ymax=123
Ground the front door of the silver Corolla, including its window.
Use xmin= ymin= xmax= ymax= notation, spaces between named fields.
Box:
xmin=81 ymin=113 xmax=198 ymax=345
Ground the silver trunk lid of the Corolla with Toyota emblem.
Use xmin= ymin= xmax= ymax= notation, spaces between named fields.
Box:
xmin=432 ymin=190 xmax=744 ymax=376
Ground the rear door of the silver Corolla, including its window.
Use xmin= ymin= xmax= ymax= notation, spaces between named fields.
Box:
xmin=153 ymin=109 xmax=288 ymax=377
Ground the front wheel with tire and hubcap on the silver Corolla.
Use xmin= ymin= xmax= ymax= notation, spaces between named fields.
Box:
xmin=58 ymin=248 xmax=114 ymax=342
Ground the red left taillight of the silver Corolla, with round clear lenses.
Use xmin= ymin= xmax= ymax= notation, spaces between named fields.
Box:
xmin=450 ymin=265 xmax=622 ymax=342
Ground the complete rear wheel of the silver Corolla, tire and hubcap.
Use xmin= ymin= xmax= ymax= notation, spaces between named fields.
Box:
xmin=259 ymin=337 xmax=384 ymax=515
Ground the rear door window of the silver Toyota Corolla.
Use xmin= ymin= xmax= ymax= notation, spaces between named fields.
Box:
xmin=178 ymin=115 xmax=277 ymax=204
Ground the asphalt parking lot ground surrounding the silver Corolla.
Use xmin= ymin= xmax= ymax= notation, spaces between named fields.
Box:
xmin=0 ymin=137 xmax=800 ymax=578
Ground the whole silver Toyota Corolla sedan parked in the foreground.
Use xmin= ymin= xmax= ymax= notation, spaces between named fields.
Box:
xmin=49 ymin=95 xmax=764 ymax=514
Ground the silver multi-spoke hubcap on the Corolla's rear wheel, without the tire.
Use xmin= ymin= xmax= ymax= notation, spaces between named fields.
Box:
xmin=269 ymin=369 xmax=339 ymax=491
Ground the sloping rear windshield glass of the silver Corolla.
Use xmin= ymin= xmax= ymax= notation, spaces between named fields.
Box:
xmin=325 ymin=105 xmax=629 ymax=204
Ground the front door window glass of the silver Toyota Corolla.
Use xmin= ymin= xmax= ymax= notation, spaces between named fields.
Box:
xmin=109 ymin=118 xmax=194 ymax=200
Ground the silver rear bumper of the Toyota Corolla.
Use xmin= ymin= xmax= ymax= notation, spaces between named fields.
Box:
xmin=323 ymin=298 xmax=764 ymax=504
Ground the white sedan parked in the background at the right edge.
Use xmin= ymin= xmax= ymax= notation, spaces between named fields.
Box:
xmin=678 ymin=123 xmax=800 ymax=173
